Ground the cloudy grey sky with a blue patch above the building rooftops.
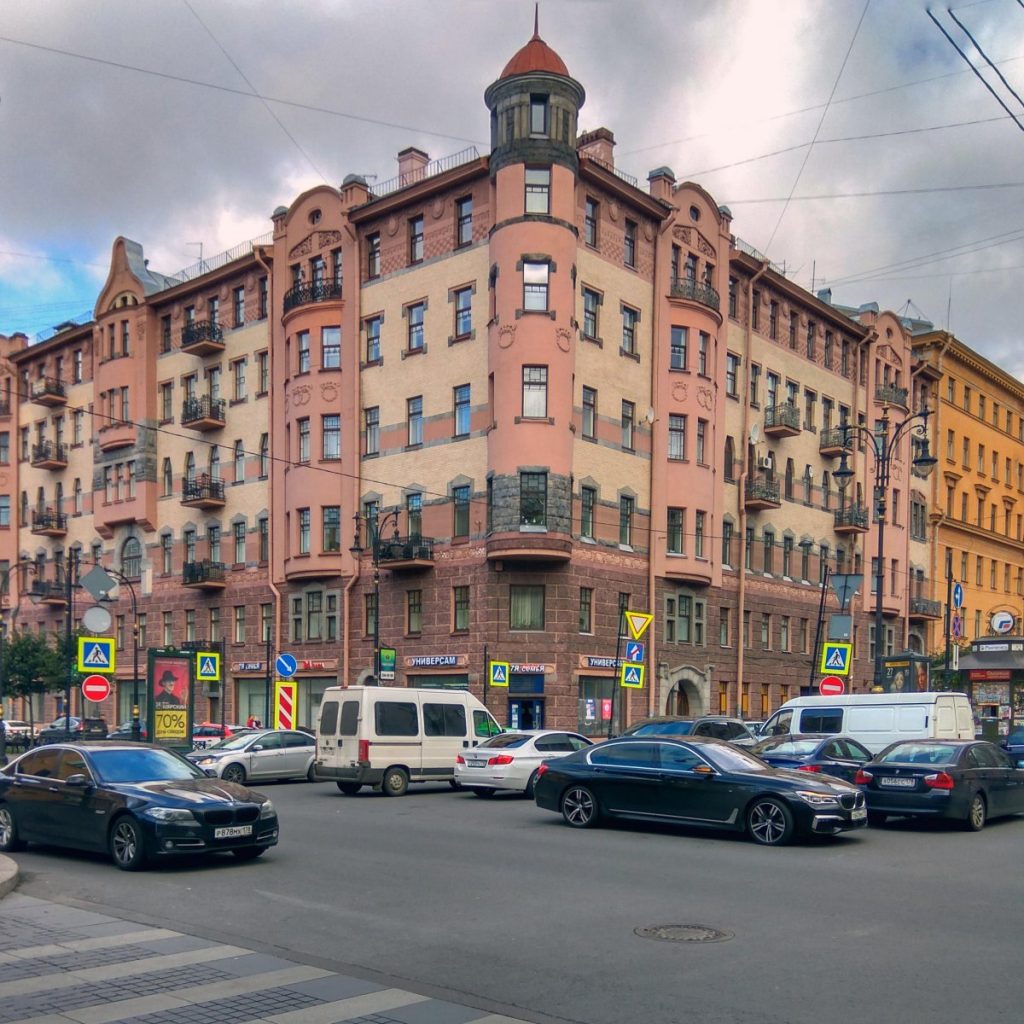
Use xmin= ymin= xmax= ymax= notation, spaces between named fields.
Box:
xmin=0 ymin=0 xmax=1024 ymax=376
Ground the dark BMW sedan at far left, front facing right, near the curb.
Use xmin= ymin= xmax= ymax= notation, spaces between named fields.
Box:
xmin=0 ymin=740 xmax=278 ymax=871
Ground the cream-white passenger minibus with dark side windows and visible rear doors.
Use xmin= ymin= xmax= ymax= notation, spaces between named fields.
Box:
xmin=315 ymin=686 xmax=503 ymax=797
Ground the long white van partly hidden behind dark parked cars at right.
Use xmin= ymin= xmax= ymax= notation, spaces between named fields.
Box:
xmin=758 ymin=692 xmax=974 ymax=754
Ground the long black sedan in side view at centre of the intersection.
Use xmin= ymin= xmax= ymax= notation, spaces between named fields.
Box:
xmin=535 ymin=736 xmax=867 ymax=846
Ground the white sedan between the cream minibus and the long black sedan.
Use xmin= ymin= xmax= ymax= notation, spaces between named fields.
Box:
xmin=455 ymin=729 xmax=593 ymax=797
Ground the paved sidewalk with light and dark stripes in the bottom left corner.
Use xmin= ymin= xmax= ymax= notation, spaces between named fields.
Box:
xmin=0 ymin=855 xmax=540 ymax=1024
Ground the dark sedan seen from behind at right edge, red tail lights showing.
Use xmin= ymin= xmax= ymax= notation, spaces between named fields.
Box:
xmin=856 ymin=739 xmax=1024 ymax=831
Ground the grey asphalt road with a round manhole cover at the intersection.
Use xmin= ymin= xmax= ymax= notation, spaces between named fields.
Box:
xmin=9 ymin=783 xmax=1024 ymax=1024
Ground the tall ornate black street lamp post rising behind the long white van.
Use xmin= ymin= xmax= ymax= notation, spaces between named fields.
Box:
xmin=834 ymin=404 xmax=937 ymax=686
